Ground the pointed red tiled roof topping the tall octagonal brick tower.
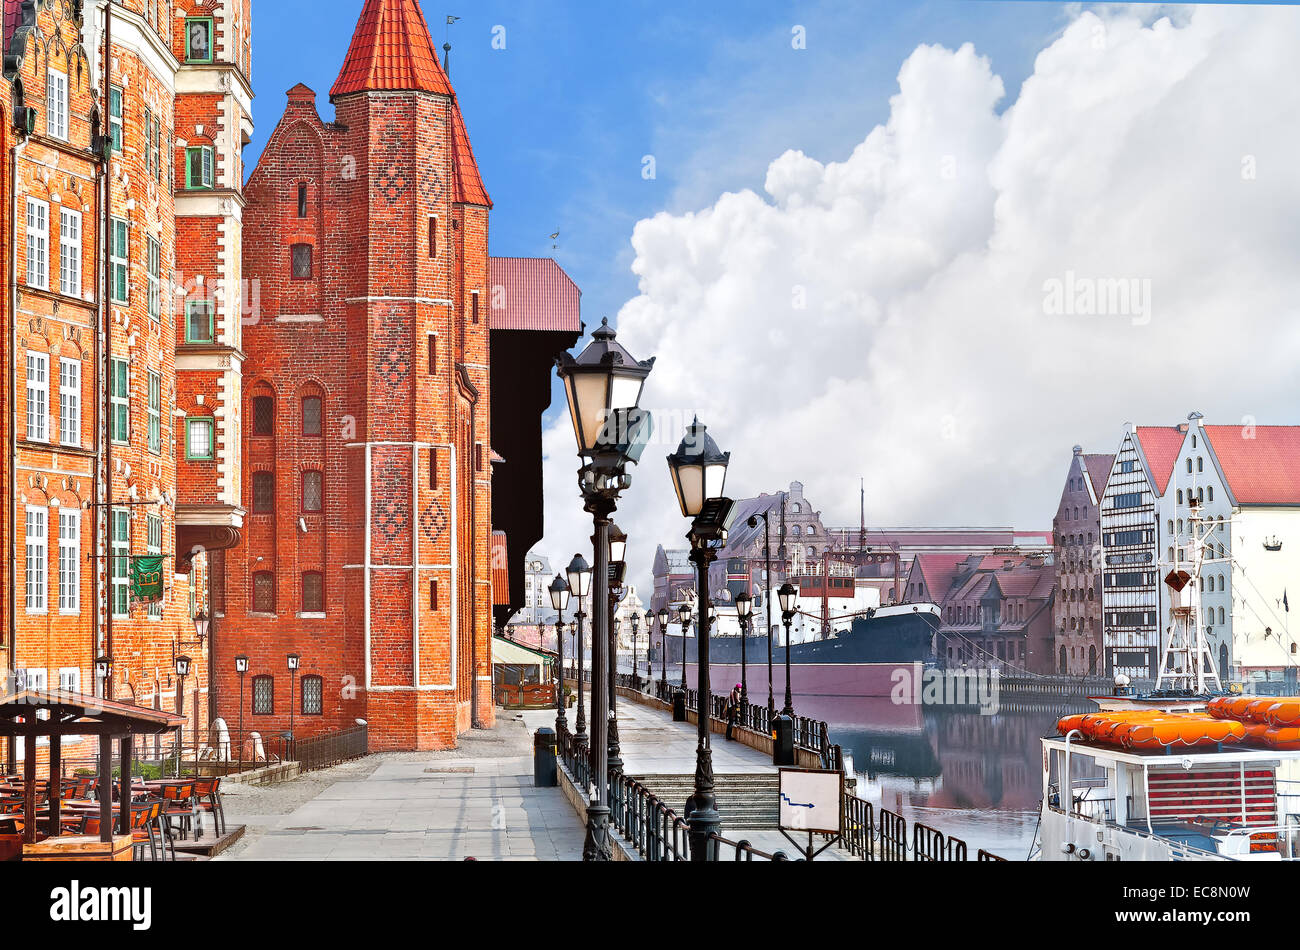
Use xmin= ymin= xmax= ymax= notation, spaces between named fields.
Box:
xmin=329 ymin=0 xmax=451 ymax=100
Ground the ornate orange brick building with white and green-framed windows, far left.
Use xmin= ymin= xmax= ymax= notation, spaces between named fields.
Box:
xmin=0 ymin=0 xmax=252 ymax=758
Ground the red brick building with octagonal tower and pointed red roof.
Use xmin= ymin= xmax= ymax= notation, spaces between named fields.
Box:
xmin=215 ymin=0 xmax=493 ymax=750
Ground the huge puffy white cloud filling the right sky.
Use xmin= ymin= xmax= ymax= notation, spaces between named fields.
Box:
xmin=533 ymin=6 xmax=1300 ymax=584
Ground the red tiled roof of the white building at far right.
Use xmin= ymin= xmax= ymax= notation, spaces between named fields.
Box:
xmin=1205 ymin=425 xmax=1300 ymax=504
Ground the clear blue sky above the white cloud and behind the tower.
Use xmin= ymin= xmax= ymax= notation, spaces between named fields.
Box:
xmin=247 ymin=0 xmax=1065 ymax=413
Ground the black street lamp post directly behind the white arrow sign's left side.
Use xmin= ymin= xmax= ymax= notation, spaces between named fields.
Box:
xmin=668 ymin=420 xmax=735 ymax=862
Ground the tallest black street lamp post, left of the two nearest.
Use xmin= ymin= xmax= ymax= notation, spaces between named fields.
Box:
xmin=556 ymin=321 xmax=654 ymax=860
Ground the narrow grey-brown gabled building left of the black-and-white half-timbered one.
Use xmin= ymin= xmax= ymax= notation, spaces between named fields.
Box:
xmin=1052 ymin=446 xmax=1115 ymax=676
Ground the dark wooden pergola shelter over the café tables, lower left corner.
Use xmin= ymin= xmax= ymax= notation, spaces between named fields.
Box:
xmin=0 ymin=690 xmax=185 ymax=845
